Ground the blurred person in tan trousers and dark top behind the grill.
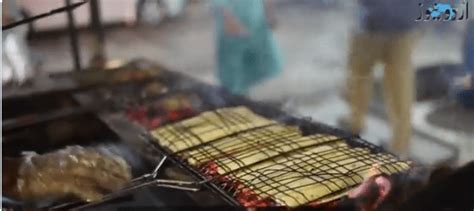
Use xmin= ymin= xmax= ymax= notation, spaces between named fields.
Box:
xmin=342 ymin=0 xmax=419 ymax=157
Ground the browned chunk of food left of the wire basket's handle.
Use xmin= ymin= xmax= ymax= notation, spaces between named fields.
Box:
xmin=4 ymin=146 xmax=132 ymax=201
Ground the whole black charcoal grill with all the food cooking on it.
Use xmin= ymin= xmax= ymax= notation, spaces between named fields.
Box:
xmin=2 ymin=61 xmax=474 ymax=211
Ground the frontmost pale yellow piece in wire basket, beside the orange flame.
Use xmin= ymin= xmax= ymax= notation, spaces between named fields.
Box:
xmin=229 ymin=145 xmax=408 ymax=207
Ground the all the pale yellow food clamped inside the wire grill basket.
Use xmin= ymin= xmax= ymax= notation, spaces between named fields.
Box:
xmin=151 ymin=107 xmax=409 ymax=207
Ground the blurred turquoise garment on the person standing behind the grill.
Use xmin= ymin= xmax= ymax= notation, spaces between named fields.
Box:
xmin=214 ymin=0 xmax=282 ymax=94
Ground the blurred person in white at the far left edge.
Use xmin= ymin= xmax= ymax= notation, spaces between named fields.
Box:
xmin=2 ymin=0 xmax=34 ymax=85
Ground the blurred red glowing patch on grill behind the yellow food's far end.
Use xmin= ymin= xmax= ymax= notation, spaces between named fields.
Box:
xmin=125 ymin=93 xmax=201 ymax=129
